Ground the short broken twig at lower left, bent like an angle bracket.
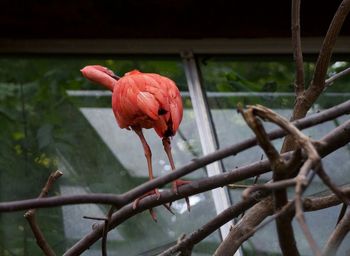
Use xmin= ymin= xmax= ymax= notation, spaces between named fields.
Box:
xmin=24 ymin=171 xmax=63 ymax=256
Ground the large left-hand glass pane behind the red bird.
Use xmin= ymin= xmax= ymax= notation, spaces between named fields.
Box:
xmin=0 ymin=57 xmax=219 ymax=255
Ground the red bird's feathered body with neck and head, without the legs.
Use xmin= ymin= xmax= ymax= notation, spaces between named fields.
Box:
xmin=82 ymin=66 xmax=183 ymax=137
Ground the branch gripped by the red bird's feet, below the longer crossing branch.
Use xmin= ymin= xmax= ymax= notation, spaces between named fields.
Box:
xmin=65 ymin=121 xmax=350 ymax=256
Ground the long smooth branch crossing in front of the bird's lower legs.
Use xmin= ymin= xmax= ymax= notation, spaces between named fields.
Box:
xmin=0 ymin=100 xmax=350 ymax=212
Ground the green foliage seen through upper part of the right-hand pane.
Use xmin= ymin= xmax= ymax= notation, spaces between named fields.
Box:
xmin=200 ymin=57 xmax=350 ymax=109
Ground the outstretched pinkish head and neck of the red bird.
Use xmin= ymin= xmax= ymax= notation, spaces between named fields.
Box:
xmin=80 ymin=65 xmax=120 ymax=91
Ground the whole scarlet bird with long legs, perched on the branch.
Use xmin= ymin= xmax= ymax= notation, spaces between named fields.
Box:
xmin=81 ymin=65 xmax=190 ymax=221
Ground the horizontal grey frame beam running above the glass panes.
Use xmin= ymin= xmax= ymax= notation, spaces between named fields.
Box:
xmin=0 ymin=36 xmax=350 ymax=55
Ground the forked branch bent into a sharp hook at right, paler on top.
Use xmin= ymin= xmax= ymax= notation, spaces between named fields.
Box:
xmin=243 ymin=105 xmax=320 ymax=255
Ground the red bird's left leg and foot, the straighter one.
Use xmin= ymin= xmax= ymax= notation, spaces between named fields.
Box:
xmin=133 ymin=127 xmax=174 ymax=221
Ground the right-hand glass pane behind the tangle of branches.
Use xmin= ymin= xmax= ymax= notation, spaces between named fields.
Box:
xmin=200 ymin=57 xmax=350 ymax=255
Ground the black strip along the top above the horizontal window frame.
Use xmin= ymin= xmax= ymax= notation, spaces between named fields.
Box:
xmin=0 ymin=0 xmax=350 ymax=39
